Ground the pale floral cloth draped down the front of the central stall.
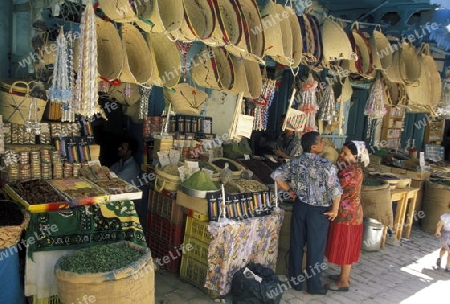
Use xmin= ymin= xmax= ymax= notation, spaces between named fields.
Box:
xmin=204 ymin=210 xmax=284 ymax=295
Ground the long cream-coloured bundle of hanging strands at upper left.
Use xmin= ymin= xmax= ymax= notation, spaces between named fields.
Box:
xmin=73 ymin=0 xmax=103 ymax=117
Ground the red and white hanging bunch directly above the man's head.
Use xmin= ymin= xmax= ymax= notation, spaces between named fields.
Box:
xmin=296 ymin=74 xmax=319 ymax=133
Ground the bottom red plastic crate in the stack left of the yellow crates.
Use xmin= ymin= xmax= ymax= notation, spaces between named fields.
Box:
xmin=146 ymin=237 xmax=183 ymax=272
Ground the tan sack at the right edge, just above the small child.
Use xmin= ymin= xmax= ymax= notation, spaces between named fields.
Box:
xmin=421 ymin=181 xmax=450 ymax=233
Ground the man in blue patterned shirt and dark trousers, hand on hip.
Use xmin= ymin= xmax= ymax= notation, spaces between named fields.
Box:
xmin=271 ymin=131 xmax=342 ymax=294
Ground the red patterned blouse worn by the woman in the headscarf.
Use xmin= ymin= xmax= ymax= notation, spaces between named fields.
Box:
xmin=334 ymin=164 xmax=364 ymax=225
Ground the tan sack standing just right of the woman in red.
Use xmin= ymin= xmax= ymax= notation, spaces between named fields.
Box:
xmin=361 ymin=182 xmax=394 ymax=227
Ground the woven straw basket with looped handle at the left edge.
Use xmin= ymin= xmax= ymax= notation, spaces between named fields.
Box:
xmin=0 ymin=81 xmax=47 ymax=125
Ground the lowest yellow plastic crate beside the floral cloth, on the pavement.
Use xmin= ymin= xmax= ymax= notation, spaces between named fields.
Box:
xmin=180 ymin=255 xmax=221 ymax=298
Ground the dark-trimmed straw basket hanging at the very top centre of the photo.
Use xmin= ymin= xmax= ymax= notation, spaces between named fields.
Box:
xmin=213 ymin=0 xmax=243 ymax=45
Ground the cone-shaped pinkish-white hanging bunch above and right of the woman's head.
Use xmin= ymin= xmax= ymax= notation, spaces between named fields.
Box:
xmin=364 ymin=73 xmax=387 ymax=139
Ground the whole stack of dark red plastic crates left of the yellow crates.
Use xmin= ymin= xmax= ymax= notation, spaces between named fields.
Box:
xmin=147 ymin=189 xmax=185 ymax=272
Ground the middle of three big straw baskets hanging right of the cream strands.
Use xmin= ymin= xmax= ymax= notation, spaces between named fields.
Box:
xmin=119 ymin=23 xmax=158 ymax=83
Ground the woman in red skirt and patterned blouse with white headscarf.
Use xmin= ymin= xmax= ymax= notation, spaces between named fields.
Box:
xmin=325 ymin=141 xmax=369 ymax=291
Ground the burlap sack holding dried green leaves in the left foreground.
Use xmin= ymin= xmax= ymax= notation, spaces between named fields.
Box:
xmin=55 ymin=242 xmax=155 ymax=304
